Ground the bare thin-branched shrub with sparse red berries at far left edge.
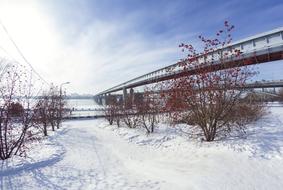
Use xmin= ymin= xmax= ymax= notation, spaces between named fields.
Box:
xmin=0 ymin=64 xmax=38 ymax=160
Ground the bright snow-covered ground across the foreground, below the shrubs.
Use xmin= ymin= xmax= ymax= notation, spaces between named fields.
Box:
xmin=0 ymin=107 xmax=283 ymax=190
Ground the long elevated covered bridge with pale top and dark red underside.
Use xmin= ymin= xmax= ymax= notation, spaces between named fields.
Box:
xmin=95 ymin=27 xmax=283 ymax=102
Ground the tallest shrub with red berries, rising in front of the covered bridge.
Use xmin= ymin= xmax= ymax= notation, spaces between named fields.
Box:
xmin=166 ymin=21 xmax=262 ymax=141
